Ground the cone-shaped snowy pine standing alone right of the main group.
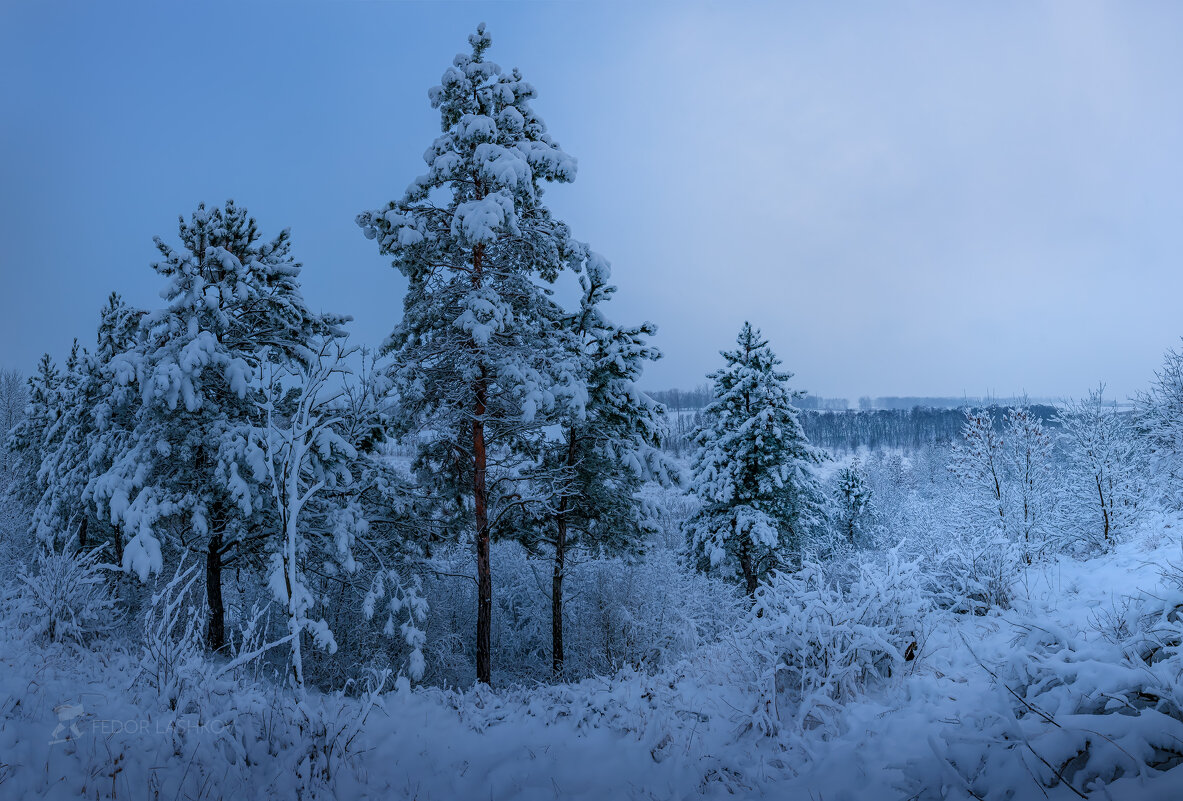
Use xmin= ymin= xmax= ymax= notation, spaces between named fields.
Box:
xmin=687 ymin=322 xmax=827 ymax=595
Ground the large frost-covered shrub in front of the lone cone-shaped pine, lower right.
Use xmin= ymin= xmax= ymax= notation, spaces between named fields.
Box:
xmin=743 ymin=551 xmax=927 ymax=734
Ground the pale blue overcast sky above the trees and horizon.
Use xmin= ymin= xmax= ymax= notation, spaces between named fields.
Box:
xmin=0 ymin=0 xmax=1183 ymax=398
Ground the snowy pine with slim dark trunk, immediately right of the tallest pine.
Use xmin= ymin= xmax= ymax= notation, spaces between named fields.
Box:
xmin=506 ymin=253 xmax=681 ymax=676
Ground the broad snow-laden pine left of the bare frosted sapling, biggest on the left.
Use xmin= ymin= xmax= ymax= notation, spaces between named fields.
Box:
xmin=86 ymin=201 xmax=347 ymax=651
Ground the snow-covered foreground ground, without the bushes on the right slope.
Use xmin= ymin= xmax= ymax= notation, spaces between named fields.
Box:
xmin=0 ymin=519 xmax=1183 ymax=801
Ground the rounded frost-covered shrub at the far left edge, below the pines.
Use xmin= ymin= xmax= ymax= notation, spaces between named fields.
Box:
xmin=12 ymin=539 xmax=116 ymax=645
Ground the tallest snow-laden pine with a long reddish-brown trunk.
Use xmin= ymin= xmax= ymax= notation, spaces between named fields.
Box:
xmin=357 ymin=25 xmax=587 ymax=683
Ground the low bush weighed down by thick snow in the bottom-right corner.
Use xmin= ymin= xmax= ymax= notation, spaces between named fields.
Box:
xmin=912 ymin=628 xmax=1183 ymax=800
